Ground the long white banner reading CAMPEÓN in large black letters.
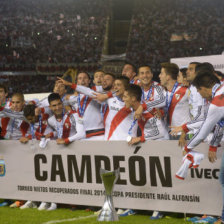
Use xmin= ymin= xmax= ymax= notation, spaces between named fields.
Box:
xmin=0 ymin=141 xmax=222 ymax=215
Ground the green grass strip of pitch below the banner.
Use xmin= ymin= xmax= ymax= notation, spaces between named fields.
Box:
xmin=0 ymin=207 xmax=190 ymax=224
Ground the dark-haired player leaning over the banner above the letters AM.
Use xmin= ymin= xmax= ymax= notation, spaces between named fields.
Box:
xmin=46 ymin=93 xmax=85 ymax=144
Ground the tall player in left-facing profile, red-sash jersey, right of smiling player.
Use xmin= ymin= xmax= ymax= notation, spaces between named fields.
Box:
xmin=135 ymin=63 xmax=190 ymax=130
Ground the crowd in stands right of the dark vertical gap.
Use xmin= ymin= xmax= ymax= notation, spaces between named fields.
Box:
xmin=127 ymin=0 xmax=224 ymax=71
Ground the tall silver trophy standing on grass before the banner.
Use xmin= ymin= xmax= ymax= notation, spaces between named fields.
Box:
xmin=97 ymin=169 xmax=120 ymax=221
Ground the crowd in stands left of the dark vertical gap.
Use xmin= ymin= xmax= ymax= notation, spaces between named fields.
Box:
xmin=0 ymin=0 xmax=109 ymax=70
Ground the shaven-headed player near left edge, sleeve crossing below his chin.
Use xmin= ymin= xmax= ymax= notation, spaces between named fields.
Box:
xmin=0 ymin=93 xmax=29 ymax=140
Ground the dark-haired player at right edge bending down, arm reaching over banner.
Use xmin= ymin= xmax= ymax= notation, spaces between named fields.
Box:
xmin=178 ymin=71 xmax=224 ymax=220
